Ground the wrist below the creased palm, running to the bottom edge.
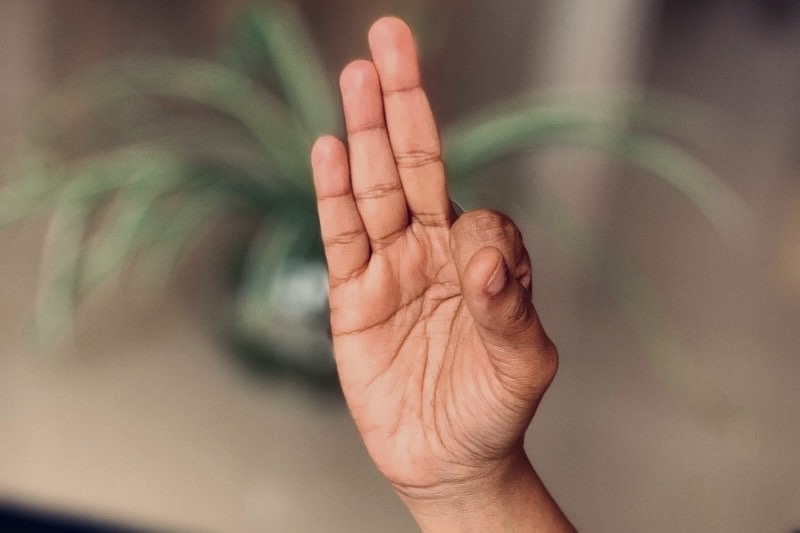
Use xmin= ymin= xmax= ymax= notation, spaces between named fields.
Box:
xmin=395 ymin=448 xmax=574 ymax=533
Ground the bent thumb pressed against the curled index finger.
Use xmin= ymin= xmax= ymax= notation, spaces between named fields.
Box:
xmin=461 ymin=246 xmax=558 ymax=387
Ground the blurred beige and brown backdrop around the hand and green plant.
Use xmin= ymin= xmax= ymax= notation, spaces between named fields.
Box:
xmin=0 ymin=0 xmax=800 ymax=532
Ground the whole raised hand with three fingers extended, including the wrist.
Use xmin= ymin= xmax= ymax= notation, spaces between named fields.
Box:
xmin=312 ymin=18 xmax=571 ymax=532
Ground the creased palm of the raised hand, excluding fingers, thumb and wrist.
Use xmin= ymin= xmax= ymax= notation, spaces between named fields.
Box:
xmin=331 ymin=222 xmax=513 ymax=487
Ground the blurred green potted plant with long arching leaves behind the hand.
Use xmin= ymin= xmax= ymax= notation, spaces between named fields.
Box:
xmin=0 ymin=3 xmax=747 ymax=384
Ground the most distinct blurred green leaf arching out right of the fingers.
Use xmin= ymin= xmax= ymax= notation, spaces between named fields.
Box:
xmin=444 ymin=104 xmax=752 ymax=238
